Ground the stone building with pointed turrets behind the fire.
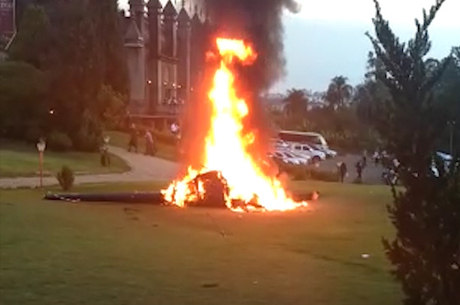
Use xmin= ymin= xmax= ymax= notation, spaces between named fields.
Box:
xmin=124 ymin=0 xmax=207 ymax=117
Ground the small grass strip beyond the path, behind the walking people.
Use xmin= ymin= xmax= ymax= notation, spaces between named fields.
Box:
xmin=106 ymin=131 xmax=177 ymax=161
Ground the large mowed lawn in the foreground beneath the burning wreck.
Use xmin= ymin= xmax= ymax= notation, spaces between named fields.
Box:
xmin=0 ymin=182 xmax=401 ymax=305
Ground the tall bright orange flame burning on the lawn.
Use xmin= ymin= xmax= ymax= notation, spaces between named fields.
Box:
xmin=162 ymin=38 xmax=307 ymax=211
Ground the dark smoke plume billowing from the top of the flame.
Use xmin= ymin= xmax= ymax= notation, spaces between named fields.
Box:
xmin=205 ymin=0 xmax=298 ymax=94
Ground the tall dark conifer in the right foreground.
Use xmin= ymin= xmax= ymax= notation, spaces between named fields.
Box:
xmin=368 ymin=0 xmax=460 ymax=305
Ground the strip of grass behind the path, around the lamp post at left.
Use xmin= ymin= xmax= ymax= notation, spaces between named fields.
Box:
xmin=0 ymin=142 xmax=129 ymax=177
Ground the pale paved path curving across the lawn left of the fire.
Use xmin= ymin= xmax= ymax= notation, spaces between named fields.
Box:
xmin=0 ymin=146 xmax=179 ymax=188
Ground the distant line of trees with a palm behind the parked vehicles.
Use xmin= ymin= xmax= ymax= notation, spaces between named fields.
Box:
xmin=271 ymin=46 xmax=460 ymax=153
